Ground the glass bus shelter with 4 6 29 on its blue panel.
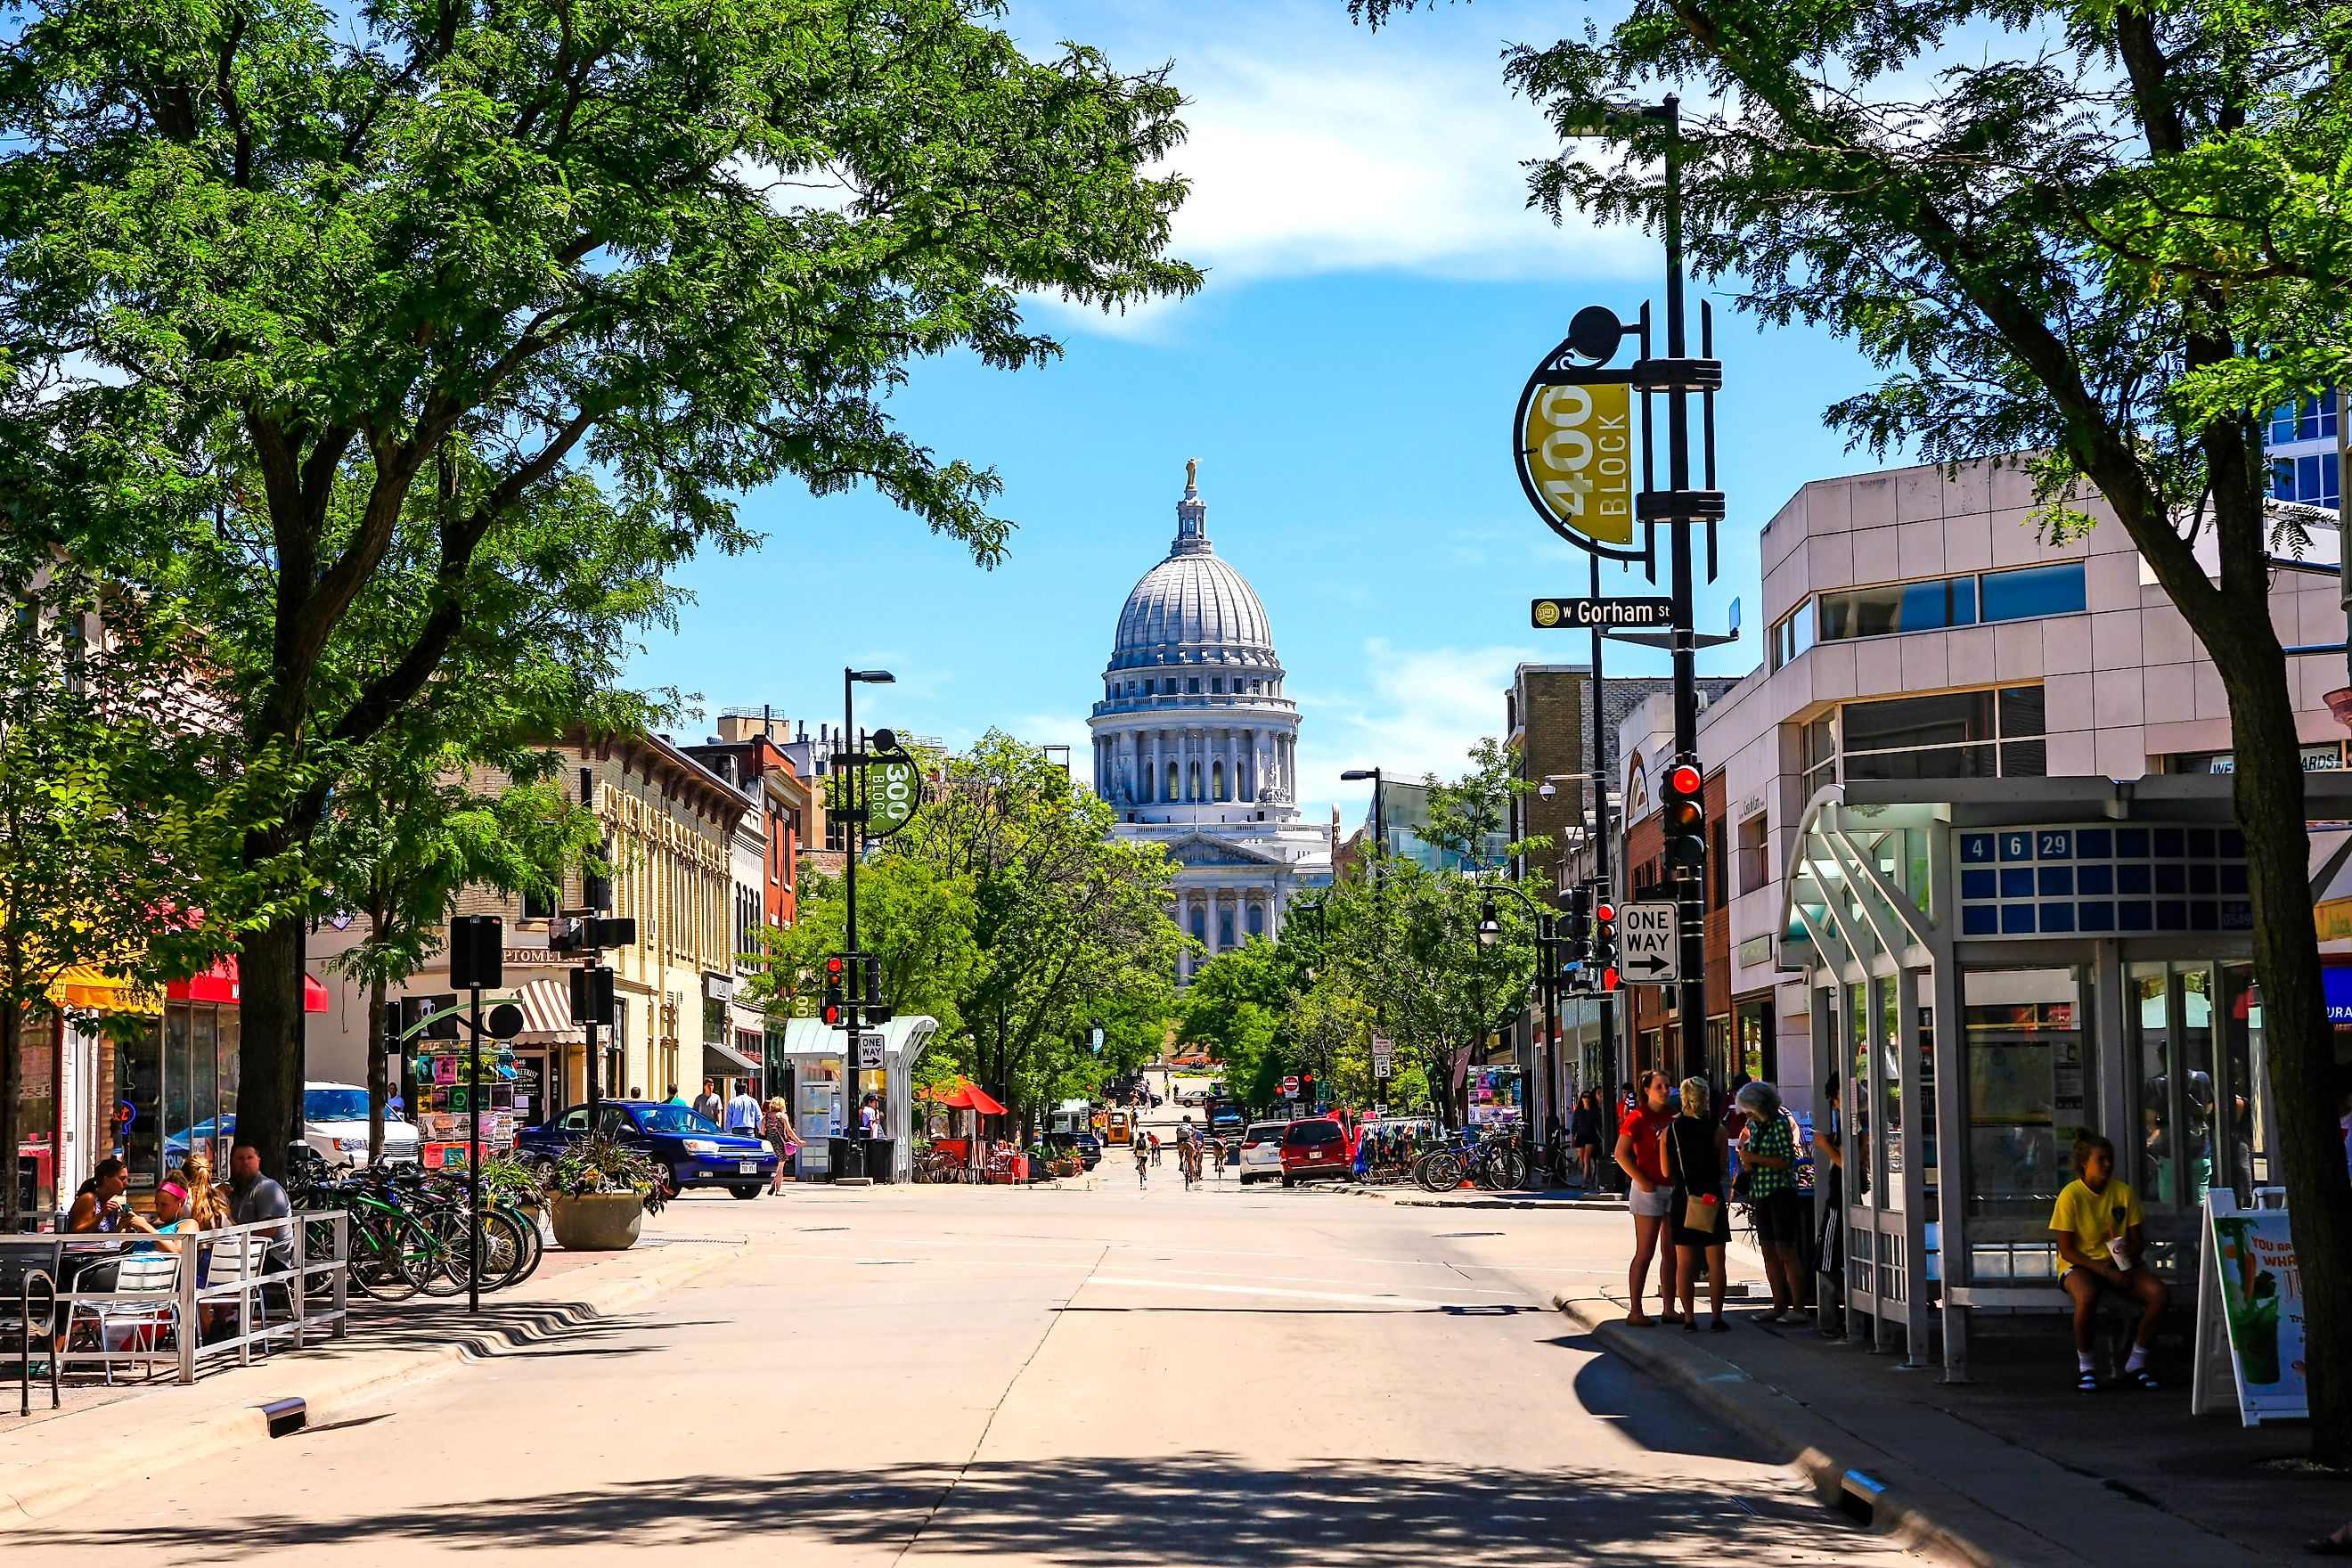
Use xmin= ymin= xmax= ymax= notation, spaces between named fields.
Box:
xmin=1780 ymin=776 xmax=2295 ymax=1383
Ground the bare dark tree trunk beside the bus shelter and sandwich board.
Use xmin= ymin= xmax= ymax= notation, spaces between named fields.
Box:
xmin=2213 ymin=643 xmax=2352 ymax=1467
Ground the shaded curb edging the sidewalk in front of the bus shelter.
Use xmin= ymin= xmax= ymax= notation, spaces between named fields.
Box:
xmin=1550 ymin=1295 xmax=2258 ymax=1568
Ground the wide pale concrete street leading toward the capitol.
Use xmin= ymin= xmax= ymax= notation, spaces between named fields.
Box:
xmin=0 ymin=1189 xmax=1903 ymax=1568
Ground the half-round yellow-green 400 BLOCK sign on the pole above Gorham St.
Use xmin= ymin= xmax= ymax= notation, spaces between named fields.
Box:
xmin=1510 ymin=343 xmax=1644 ymax=559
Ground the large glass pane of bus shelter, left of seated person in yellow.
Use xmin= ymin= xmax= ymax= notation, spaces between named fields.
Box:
xmin=1962 ymin=966 xmax=2094 ymax=1220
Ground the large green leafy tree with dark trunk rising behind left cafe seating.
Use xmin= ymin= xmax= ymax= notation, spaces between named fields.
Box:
xmin=0 ymin=0 xmax=1199 ymax=1159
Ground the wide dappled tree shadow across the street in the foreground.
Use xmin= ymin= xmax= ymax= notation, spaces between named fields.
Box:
xmin=43 ymin=1453 xmax=1893 ymax=1568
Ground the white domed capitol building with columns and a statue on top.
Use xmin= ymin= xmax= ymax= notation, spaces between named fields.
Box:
xmin=1087 ymin=461 xmax=1331 ymax=973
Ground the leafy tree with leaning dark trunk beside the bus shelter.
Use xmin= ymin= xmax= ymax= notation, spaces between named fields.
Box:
xmin=1350 ymin=0 xmax=2352 ymax=1467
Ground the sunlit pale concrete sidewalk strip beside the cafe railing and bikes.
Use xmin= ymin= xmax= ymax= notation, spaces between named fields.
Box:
xmin=0 ymin=1239 xmax=746 ymax=1519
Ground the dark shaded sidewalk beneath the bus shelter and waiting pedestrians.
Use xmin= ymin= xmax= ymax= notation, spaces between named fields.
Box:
xmin=1552 ymin=1293 xmax=2323 ymax=1568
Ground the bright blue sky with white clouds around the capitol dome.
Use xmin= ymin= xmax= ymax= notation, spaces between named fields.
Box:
xmin=635 ymin=0 xmax=1900 ymax=823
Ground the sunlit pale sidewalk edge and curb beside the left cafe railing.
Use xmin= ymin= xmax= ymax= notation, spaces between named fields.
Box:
xmin=0 ymin=1244 xmax=746 ymax=1528
